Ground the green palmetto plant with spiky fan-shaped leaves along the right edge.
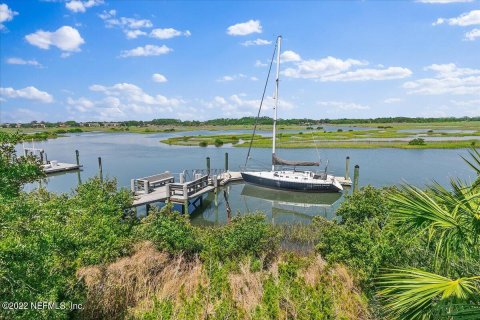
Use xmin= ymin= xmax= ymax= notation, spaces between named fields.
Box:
xmin=379 ymin=149 xmax=480 ymax=319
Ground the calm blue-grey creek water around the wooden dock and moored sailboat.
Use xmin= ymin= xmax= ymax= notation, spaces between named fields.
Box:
xmin=19 ymin=131 xmax=473 ymax=224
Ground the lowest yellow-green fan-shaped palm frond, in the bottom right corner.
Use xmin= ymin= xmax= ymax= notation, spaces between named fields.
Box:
xmin=378 ymin=269 xmax=480 ymax=319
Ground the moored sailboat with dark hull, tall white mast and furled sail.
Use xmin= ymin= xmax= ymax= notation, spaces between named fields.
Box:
xmin=241 ymin=36 xmax=343 ymax=192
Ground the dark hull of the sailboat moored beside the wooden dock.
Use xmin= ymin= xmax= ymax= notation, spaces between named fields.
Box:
xmin=242 ymin=172 xmax=341 ymax=192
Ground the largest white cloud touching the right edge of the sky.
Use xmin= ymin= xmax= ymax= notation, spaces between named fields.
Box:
xmin=403 ymin=63 xmax=480 ymax=95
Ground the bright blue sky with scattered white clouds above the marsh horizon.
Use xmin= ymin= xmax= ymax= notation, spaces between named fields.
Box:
xmin=0 ymin=0 xmax=480 ymax=122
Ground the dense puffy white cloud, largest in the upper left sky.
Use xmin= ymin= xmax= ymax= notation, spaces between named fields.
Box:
xmin=25 ymin=26 xmax=85 ymax=52
